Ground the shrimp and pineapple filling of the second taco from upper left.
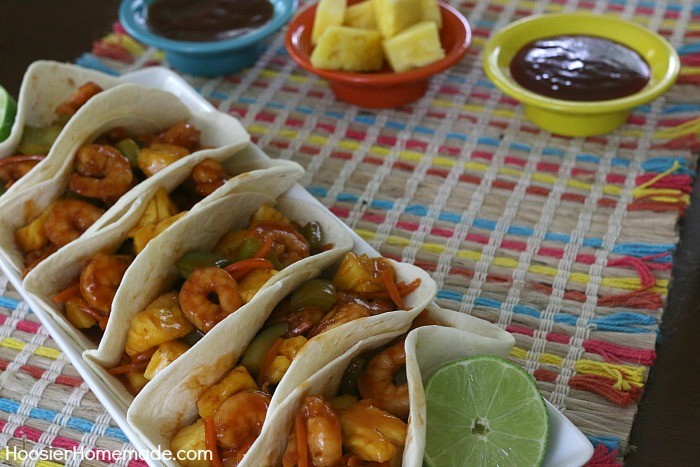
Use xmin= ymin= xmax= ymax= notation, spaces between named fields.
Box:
xmin=14 ymin=122 xmax=208 ymax=275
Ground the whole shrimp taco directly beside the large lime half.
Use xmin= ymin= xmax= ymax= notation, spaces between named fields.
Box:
xmin=249 ymin=306 xmax=515 ymax=467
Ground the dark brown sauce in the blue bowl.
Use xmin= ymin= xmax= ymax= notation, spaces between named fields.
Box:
xmin=146 ymin=0 xmax=274 ymax=42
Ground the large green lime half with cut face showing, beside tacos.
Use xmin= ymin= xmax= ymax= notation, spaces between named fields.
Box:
xmin=424 ymin=356 xmax=549 ymax=467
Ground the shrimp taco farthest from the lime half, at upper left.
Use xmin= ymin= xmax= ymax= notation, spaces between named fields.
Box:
xmin=0 ymin=60 xmax=121 ymax=193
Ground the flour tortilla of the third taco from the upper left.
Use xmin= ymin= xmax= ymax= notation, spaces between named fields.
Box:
xmin=23 ymin=148 xmax=303 ymax=352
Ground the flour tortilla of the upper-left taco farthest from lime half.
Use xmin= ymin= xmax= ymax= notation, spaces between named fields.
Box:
xmin=0 ymin=60 xmax=121 ymax=196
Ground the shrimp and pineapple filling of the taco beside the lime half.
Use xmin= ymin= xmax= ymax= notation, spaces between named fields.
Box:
xmin=282 ymin=312 xmax=440 ymax=467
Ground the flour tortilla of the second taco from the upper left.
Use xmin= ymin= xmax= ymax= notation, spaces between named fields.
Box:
xmin=0 ymin=84 xmax=250 ymax=276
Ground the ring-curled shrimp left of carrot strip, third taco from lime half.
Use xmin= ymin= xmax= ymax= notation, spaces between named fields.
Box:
xmin=180 ymin=266 xmax=243 ymax=333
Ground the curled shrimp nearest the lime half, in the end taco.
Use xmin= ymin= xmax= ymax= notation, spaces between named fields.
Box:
xmin=357 ymin=339 xmax=409 ymax=420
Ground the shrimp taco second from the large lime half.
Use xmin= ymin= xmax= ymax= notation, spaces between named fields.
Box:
xmin=122 ymin=253 xmax=435 ymax=466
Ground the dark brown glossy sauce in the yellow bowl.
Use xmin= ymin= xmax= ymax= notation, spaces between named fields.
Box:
xmin=510 ymin=35 xmax=650 ymax=101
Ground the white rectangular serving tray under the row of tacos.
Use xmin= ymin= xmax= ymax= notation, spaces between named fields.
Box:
xmin=0 ymin=67 xmax=593 ymax=467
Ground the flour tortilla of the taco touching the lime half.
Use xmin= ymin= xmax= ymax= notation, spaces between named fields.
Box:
xmin=240 ymin=304 xmax=515 ymax=467
